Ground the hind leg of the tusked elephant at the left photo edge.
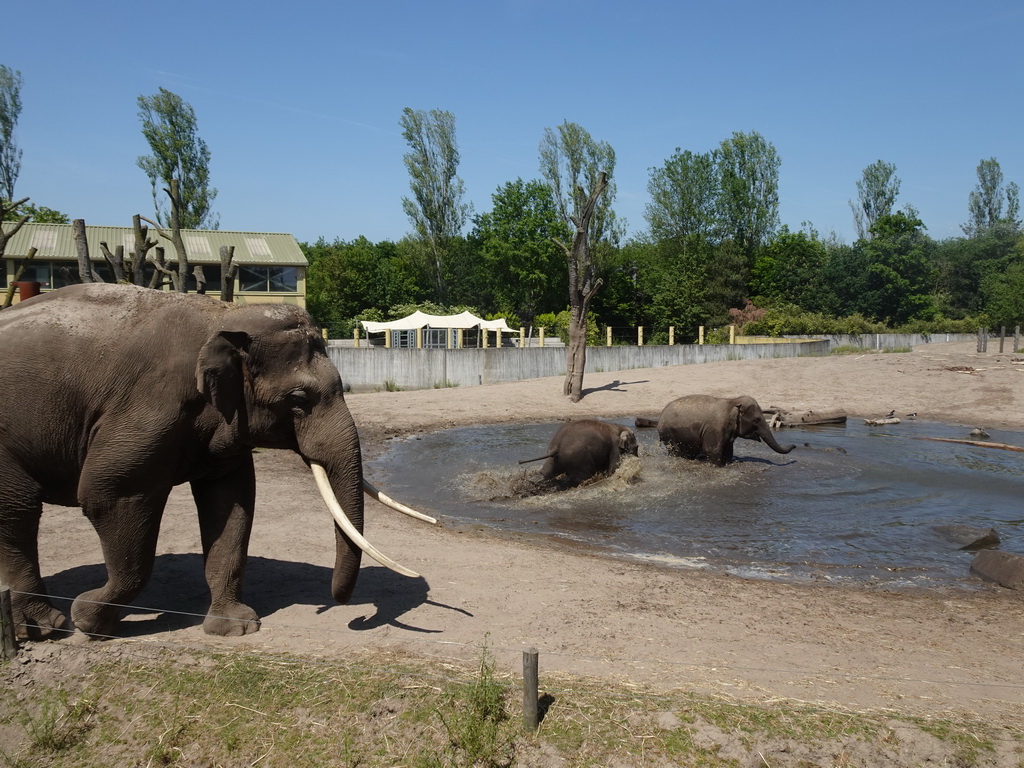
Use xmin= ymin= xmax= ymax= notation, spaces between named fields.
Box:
xmin=0 ymin=472 xmax=70 ymax=640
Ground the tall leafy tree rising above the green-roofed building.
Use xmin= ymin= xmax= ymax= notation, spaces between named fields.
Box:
xmin=137 ymin=88 xmax=219 ymax=229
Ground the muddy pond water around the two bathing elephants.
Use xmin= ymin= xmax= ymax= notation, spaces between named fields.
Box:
xmin=368 ymin=420 xmax=1024 ymax=588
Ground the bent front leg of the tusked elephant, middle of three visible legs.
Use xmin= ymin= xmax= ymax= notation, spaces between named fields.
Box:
xmin=71 ymin=492 xmax=167 ymax=637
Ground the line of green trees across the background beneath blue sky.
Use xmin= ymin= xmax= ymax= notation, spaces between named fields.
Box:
xmin=0 ymin=65 xmax=1024 ymax=343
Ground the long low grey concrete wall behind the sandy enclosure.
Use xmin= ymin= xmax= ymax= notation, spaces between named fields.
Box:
xmin=328 ymin=340 xmax=829 ymax=392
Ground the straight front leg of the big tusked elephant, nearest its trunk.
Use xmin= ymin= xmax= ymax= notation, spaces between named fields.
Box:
xmin=191 ymin=457 xmax=260 ymax=635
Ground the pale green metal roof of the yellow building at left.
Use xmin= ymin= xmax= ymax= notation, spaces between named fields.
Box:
xmin=3 ymin=222 xmax=308 ymax=266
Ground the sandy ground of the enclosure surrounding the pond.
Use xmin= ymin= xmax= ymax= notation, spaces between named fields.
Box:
xmin=32 ymin=343 xmax=1024 ymax=723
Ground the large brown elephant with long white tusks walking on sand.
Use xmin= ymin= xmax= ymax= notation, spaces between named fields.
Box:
xmin=0 ymin=284 xmax=433 ymax=638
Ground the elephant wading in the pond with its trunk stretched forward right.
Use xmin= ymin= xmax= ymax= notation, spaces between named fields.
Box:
xmin=636 ymin=394 xmax=797 ymax=467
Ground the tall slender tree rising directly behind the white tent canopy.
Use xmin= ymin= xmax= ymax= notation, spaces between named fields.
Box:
xmin=400 ymin=106 xmax=470 ymax=303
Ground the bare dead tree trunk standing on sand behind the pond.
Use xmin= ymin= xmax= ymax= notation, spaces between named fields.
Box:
xmin=555 ymin=172 xmax=608 ymax=402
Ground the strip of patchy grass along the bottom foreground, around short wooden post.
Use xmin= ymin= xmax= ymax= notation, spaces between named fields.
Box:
xmin=0 ymin=643 xmax=1024 ymax=768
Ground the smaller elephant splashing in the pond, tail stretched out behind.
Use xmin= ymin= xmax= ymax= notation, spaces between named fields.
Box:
xmin=519 ymin=419 xmax=638 ymax=485
